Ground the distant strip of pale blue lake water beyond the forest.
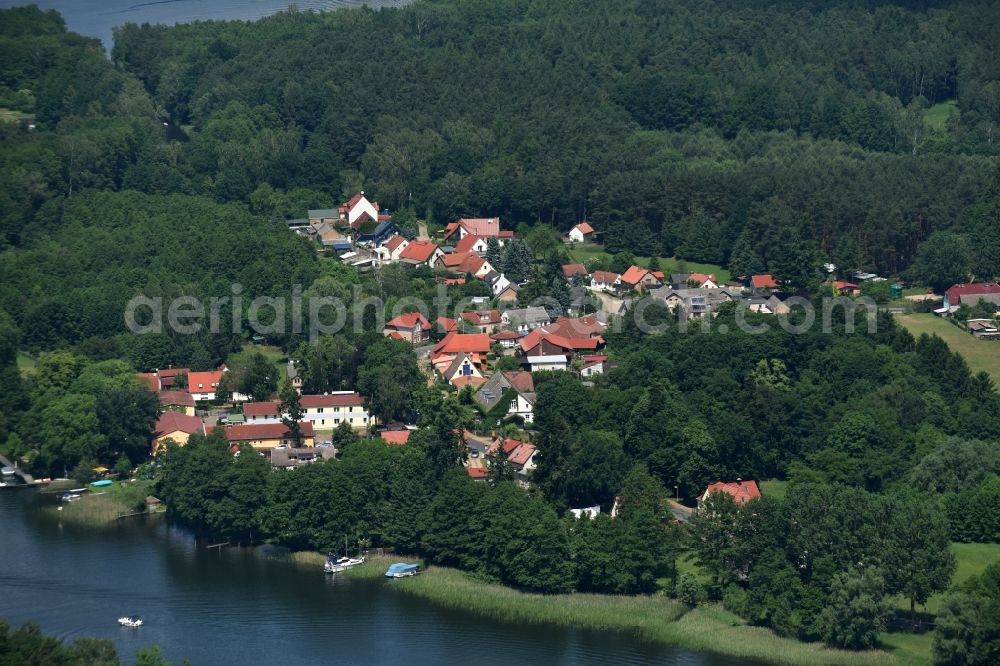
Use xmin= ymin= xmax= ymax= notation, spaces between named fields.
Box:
xmin=0 ymin=0 xmax=409 ymax=51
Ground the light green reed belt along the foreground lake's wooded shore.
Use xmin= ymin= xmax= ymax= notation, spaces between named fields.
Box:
xmin=289 ymin=551 xmax=900 ymax=666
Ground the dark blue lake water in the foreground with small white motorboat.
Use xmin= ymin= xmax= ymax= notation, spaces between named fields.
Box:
xmin=0 ymin=490 xmax=743 ymax=666
